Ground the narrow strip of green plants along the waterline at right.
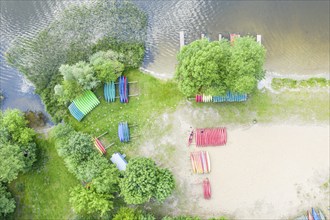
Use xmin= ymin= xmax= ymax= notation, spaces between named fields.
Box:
xmin=272 ymin=77 xmax=330 ymax=90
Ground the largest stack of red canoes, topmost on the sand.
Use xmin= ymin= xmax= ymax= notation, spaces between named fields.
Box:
xmin=195 ymin=128 xmax=227 ymax=147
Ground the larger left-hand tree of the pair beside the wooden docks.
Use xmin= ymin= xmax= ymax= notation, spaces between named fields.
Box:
xmin=175 ymin=39 xmax=230 ymax=96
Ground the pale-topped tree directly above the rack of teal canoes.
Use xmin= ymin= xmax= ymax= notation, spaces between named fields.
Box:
xmin=90 ymin=50 xmax=125 ymax=82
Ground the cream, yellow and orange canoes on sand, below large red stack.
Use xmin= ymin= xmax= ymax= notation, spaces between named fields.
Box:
xmin=190 ymin=151 xmax=211 ymax=174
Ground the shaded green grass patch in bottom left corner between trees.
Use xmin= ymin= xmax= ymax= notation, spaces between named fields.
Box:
xmin=9 ymin=139 xmax=79 ymax=219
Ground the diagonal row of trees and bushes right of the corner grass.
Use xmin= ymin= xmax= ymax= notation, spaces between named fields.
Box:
xmin=51 ymin=124 xmax=119 ymax=216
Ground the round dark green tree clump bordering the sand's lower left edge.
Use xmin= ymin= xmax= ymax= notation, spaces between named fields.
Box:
xmin=119 ymin=158 xmax=174 ymax=204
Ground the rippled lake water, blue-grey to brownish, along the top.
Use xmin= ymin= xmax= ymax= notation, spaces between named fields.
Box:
xmin=0 ymin=0 xmax=329 ymax=115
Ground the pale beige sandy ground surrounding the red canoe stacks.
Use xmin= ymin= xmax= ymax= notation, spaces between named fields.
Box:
xmin=139 ymin=106 xmax=330 ymax=219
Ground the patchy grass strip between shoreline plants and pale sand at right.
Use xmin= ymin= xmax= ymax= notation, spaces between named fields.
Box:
xmin=194 ymin=90 xmax=330 ymax=124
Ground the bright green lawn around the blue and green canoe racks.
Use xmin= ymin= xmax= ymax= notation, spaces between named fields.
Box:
xmin=67 ymin=70 xmax=184 ymax=155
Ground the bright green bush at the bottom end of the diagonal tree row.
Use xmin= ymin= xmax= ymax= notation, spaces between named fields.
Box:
xmin=70 ymin=186 xmax=113 ymax=216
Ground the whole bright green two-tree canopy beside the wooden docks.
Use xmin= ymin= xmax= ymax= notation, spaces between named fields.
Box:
xmin=175 ymin=37 xmax=265 ymax=96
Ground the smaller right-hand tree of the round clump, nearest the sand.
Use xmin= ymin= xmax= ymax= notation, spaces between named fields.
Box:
xmin=155 ymin=169 xmax=175 ymax=202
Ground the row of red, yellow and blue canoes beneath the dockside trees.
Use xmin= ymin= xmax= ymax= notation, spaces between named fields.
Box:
xmin=195 ymin=92 xmax=247 ymax=102
